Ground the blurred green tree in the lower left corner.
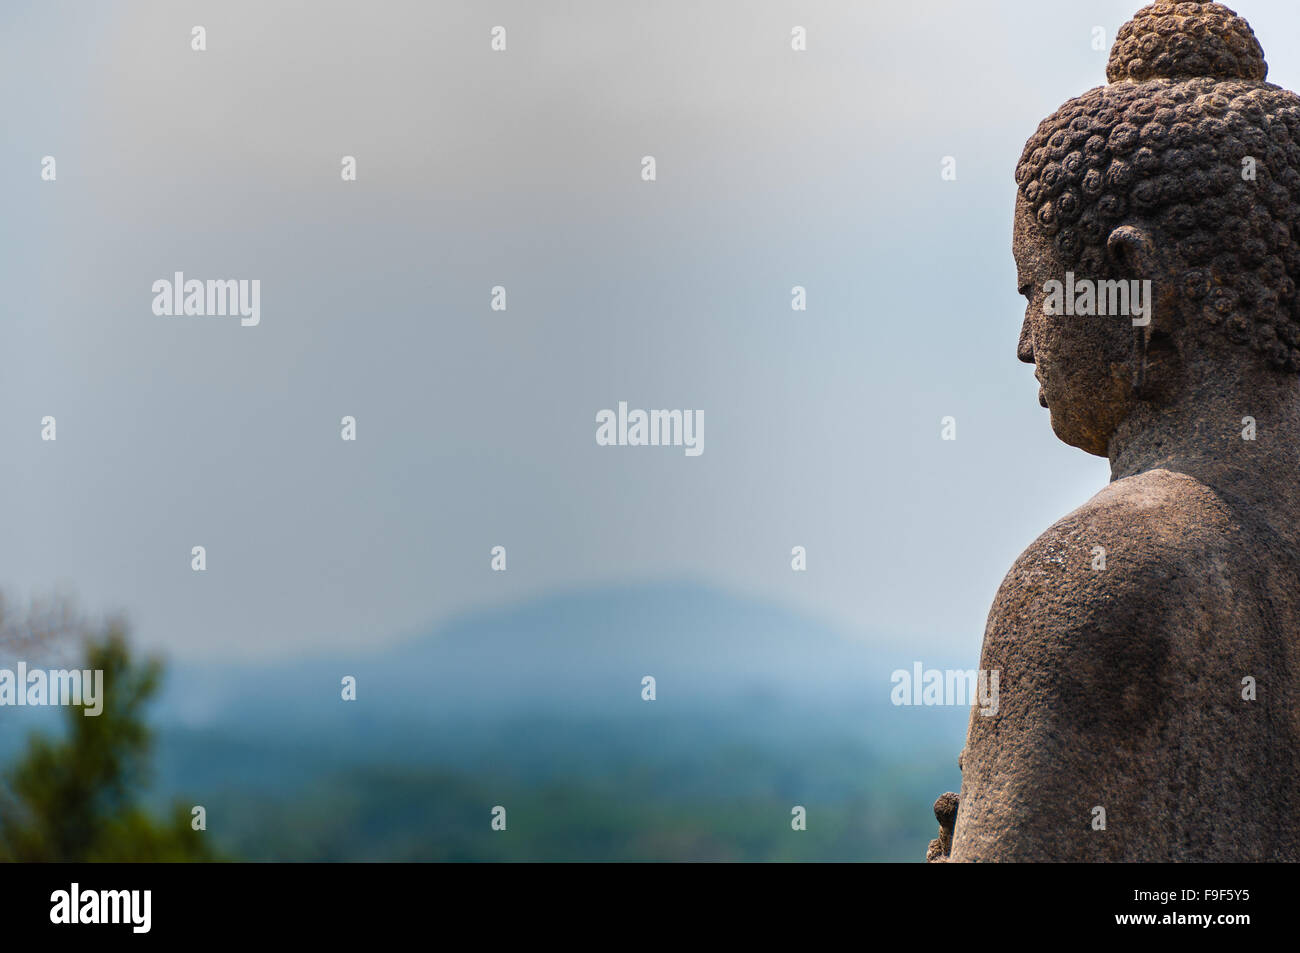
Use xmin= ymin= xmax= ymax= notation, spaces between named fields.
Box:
xmin=0 ymin=624 xmax=218 ymax=862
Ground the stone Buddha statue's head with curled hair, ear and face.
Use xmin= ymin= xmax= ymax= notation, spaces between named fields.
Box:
xmin=1013 ymin=1 xmax=1300 ymax=456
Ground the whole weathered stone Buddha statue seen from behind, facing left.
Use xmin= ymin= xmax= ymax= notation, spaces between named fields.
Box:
xmin=928 ymin=3 xmax=1300 ymax=861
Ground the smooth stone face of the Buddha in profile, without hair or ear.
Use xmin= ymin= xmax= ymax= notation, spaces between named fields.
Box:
xmin=1011 ymin=196 xmax=1135 ymax=456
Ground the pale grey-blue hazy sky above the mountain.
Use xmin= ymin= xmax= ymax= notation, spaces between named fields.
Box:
xmin=0 ymin=0 xmax=1300 ymax=658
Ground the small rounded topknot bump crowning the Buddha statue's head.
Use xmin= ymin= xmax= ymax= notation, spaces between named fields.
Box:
xmin=1106 ymin=0 xmax=1269 ymax=83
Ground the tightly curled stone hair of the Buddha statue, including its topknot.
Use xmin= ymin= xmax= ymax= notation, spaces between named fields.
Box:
xmin=1015 ymin=3 xmax=1300 ymax=373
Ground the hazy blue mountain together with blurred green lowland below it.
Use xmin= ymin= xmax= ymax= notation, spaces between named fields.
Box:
xmin=22 ymin=584 xmax=969 ymax=861
